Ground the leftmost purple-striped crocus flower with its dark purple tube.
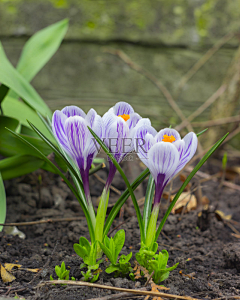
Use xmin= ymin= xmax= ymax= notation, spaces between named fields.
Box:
xmin=52 ymin=106 xmax=103 ymax=225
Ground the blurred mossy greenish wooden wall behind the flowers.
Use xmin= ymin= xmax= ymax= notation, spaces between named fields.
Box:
xmin=0 ymin=0 xmax=240 ymax=148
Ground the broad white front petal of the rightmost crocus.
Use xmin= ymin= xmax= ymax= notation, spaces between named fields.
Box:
xmin=148 ymin=142 xmax=179 ymax=184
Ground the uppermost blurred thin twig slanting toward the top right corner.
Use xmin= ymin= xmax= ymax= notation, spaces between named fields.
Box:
xmin=177 ymin=33 xmax=235 ymax=95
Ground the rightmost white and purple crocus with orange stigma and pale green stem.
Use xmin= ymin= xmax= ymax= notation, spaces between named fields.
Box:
xmin=135 ymin=126 xmax=198 ymax=246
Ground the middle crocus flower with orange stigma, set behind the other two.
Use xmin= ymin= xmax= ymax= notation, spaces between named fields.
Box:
xmin=102 ymin=102 xmax=151 ymax=190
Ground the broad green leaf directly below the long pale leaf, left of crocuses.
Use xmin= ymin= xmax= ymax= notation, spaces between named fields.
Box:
xmin=2 ymin=96 xmax=54 ymax=142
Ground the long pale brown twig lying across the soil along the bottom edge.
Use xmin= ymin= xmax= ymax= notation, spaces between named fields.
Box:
xmin=35 ymin=280 xmax=198 ymax=300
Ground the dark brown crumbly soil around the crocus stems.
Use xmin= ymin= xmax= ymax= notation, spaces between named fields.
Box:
xmin=0 ymin=158 xmax=240 ymax=300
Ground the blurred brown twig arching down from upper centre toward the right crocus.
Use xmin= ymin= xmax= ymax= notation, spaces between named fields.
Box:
xmin=104 ymin=48 xmax=197 ymax=135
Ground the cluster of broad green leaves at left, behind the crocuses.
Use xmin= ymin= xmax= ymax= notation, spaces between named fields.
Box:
xmin=0 ymin=19 xmax=68 ymax=179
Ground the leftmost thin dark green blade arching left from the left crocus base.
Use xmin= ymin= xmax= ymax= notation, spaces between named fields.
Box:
xmin=6 ymin=128 xmax=95 ymax=242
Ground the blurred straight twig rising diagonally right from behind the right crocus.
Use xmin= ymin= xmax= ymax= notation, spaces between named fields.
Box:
xmin=175 ymin=84 xmax=227 ymax=131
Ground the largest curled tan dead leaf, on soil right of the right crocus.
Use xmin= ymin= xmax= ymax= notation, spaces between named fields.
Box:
xmin=171 ymin=192 xmax=197 ymax=214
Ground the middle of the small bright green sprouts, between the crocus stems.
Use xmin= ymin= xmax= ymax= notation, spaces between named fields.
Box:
xmin=99 ymin=229 xmax=132 ymax=276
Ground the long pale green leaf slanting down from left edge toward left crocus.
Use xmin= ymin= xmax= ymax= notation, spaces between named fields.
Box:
xmin=0 ymin=43 xmax=52 ymax=117
